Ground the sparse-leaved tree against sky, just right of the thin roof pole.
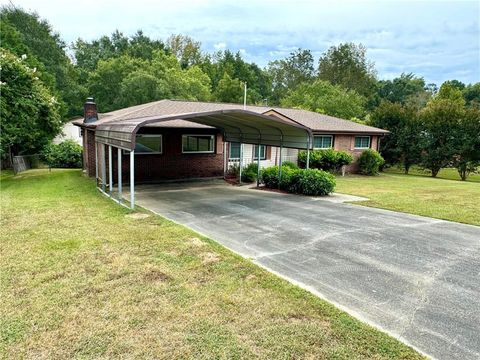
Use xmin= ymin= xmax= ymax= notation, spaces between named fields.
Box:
xmin=267 ymin=49 xmax=315 ymax=104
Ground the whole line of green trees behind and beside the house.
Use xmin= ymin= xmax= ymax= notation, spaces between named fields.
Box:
xmin=0 ymin=5 xmax=480 ymax=178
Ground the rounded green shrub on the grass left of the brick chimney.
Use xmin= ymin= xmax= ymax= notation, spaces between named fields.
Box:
xmin=42 ymin=140 xmax=82 ymax=168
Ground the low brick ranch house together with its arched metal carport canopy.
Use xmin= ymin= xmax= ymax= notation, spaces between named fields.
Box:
xmin=73 ymin=98 xmax=388 ymax=190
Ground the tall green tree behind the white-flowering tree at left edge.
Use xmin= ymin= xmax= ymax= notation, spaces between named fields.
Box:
xmin=0 ymin=5 xmax=85 ymax=117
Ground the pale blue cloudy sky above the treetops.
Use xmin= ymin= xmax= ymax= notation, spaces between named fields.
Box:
xmin=4 ymin=0 xmax=480 ymax=84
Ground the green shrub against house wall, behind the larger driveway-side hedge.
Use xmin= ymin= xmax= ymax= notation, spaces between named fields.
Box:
xmin=298 ymin=149 xmax=353 ymax=172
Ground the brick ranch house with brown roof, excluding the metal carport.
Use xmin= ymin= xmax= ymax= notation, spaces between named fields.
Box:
xmin=73 ymin=100 xmax=388 ymax=182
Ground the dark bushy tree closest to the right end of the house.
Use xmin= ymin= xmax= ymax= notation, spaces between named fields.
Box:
xmin=370 ymin=101 xmax=421 ymax=174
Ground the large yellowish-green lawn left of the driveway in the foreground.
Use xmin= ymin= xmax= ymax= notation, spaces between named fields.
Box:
xmin=0 ymin=170 xmax=421 ymax=359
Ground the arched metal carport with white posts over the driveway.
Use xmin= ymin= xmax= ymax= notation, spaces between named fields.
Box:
xmin=95 ymin=109 xmax=313 ymax=209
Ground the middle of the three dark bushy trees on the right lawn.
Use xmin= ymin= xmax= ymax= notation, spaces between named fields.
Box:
xmin=421 ymin=83 xmax=465 ymax=177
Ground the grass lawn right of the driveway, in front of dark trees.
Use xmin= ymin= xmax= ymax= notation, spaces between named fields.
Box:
xmin=335 ymin=168 xmax=480 ymax=225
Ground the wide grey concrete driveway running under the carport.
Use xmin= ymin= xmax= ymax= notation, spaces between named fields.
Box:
xmin=133 ymin=183 xmax=480 ymax=359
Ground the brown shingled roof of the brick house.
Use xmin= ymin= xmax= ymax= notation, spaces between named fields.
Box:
xmin=74 ymin=100 xmax=388 ymax=134
